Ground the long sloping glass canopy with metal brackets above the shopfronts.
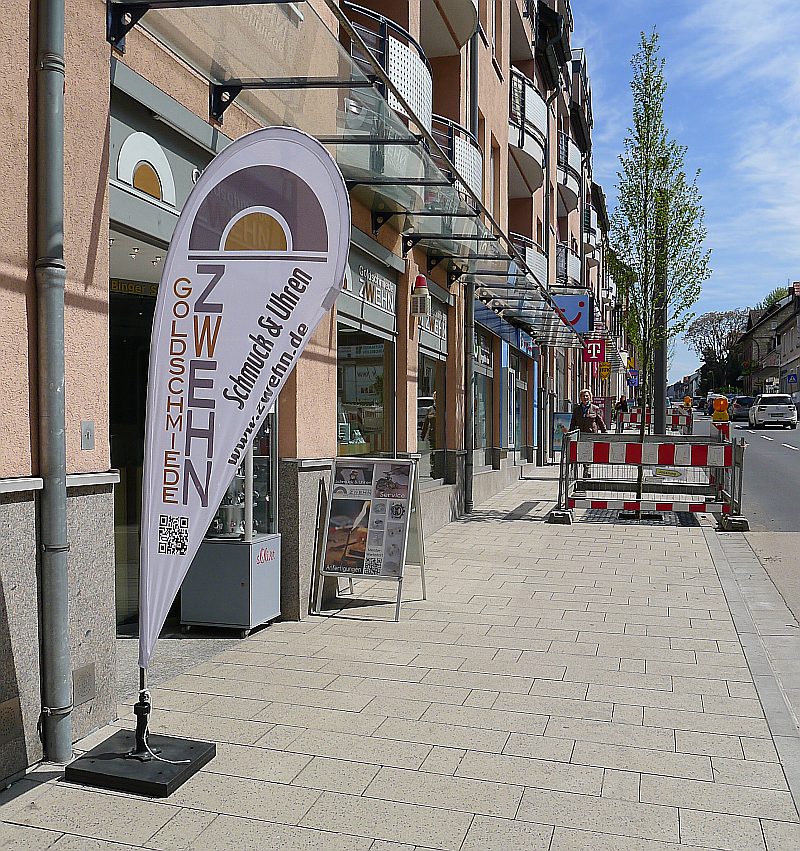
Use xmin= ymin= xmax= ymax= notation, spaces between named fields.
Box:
xmin=109 ymin=0 xmax=581 ymax=347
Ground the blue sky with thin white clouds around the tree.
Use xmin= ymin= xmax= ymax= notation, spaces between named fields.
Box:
xmin=572 ymin=0 xmax=800 ymax=382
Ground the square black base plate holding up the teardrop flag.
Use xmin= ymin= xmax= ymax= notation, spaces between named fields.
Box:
xmin=64 ymin=730 xmax=217 ymax=798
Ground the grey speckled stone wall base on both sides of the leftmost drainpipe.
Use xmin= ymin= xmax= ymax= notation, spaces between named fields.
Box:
xmin=0 ymin=485 xmax=116 ymax=784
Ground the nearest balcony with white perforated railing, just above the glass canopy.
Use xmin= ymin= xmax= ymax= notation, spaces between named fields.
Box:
xmin=342 ymin=2 xmax=433 ymax=131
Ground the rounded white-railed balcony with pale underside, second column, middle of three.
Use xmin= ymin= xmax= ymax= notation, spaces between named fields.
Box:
xmin=508 ymin=68 xmax=547 ymax=198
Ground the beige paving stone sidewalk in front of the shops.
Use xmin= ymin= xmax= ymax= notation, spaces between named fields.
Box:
xmin=0 ymin=471 xmax=800 ymax=851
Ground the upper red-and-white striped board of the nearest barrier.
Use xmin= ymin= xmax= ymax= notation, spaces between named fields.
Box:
xmin=569 ymin=438 xmax=733 ymax=466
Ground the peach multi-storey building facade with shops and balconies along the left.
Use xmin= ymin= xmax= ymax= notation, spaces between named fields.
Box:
xmin=0 ymin=0 xmax=628 ymax=779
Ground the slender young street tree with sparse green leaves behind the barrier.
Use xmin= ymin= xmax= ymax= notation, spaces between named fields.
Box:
xmin=609 ymin=30 xmax=710 ymax=440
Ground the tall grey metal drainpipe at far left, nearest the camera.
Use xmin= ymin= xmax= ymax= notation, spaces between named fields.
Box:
xmin=35 ymin=0 xmax=72 ymax=763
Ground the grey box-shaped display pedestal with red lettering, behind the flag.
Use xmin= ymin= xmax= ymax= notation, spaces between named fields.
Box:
xmin=181 ymin=535 xmax=281 ymax=638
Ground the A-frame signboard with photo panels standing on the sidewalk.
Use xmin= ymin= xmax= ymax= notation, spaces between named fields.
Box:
xmin=314 ymin=458 xmax=427 ymax=621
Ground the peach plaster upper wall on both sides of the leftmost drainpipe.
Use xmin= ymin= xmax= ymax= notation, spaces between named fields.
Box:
xmin=0 ymin=0 xmax=109 ymax=477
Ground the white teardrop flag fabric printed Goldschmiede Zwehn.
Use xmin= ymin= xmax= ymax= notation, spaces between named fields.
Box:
xmin=139 ymin=127 xmax=350 ymax=668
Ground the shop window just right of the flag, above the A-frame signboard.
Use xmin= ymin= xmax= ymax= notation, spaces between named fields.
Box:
xmin=336 ymin=324 xmax=394 ymax=455
